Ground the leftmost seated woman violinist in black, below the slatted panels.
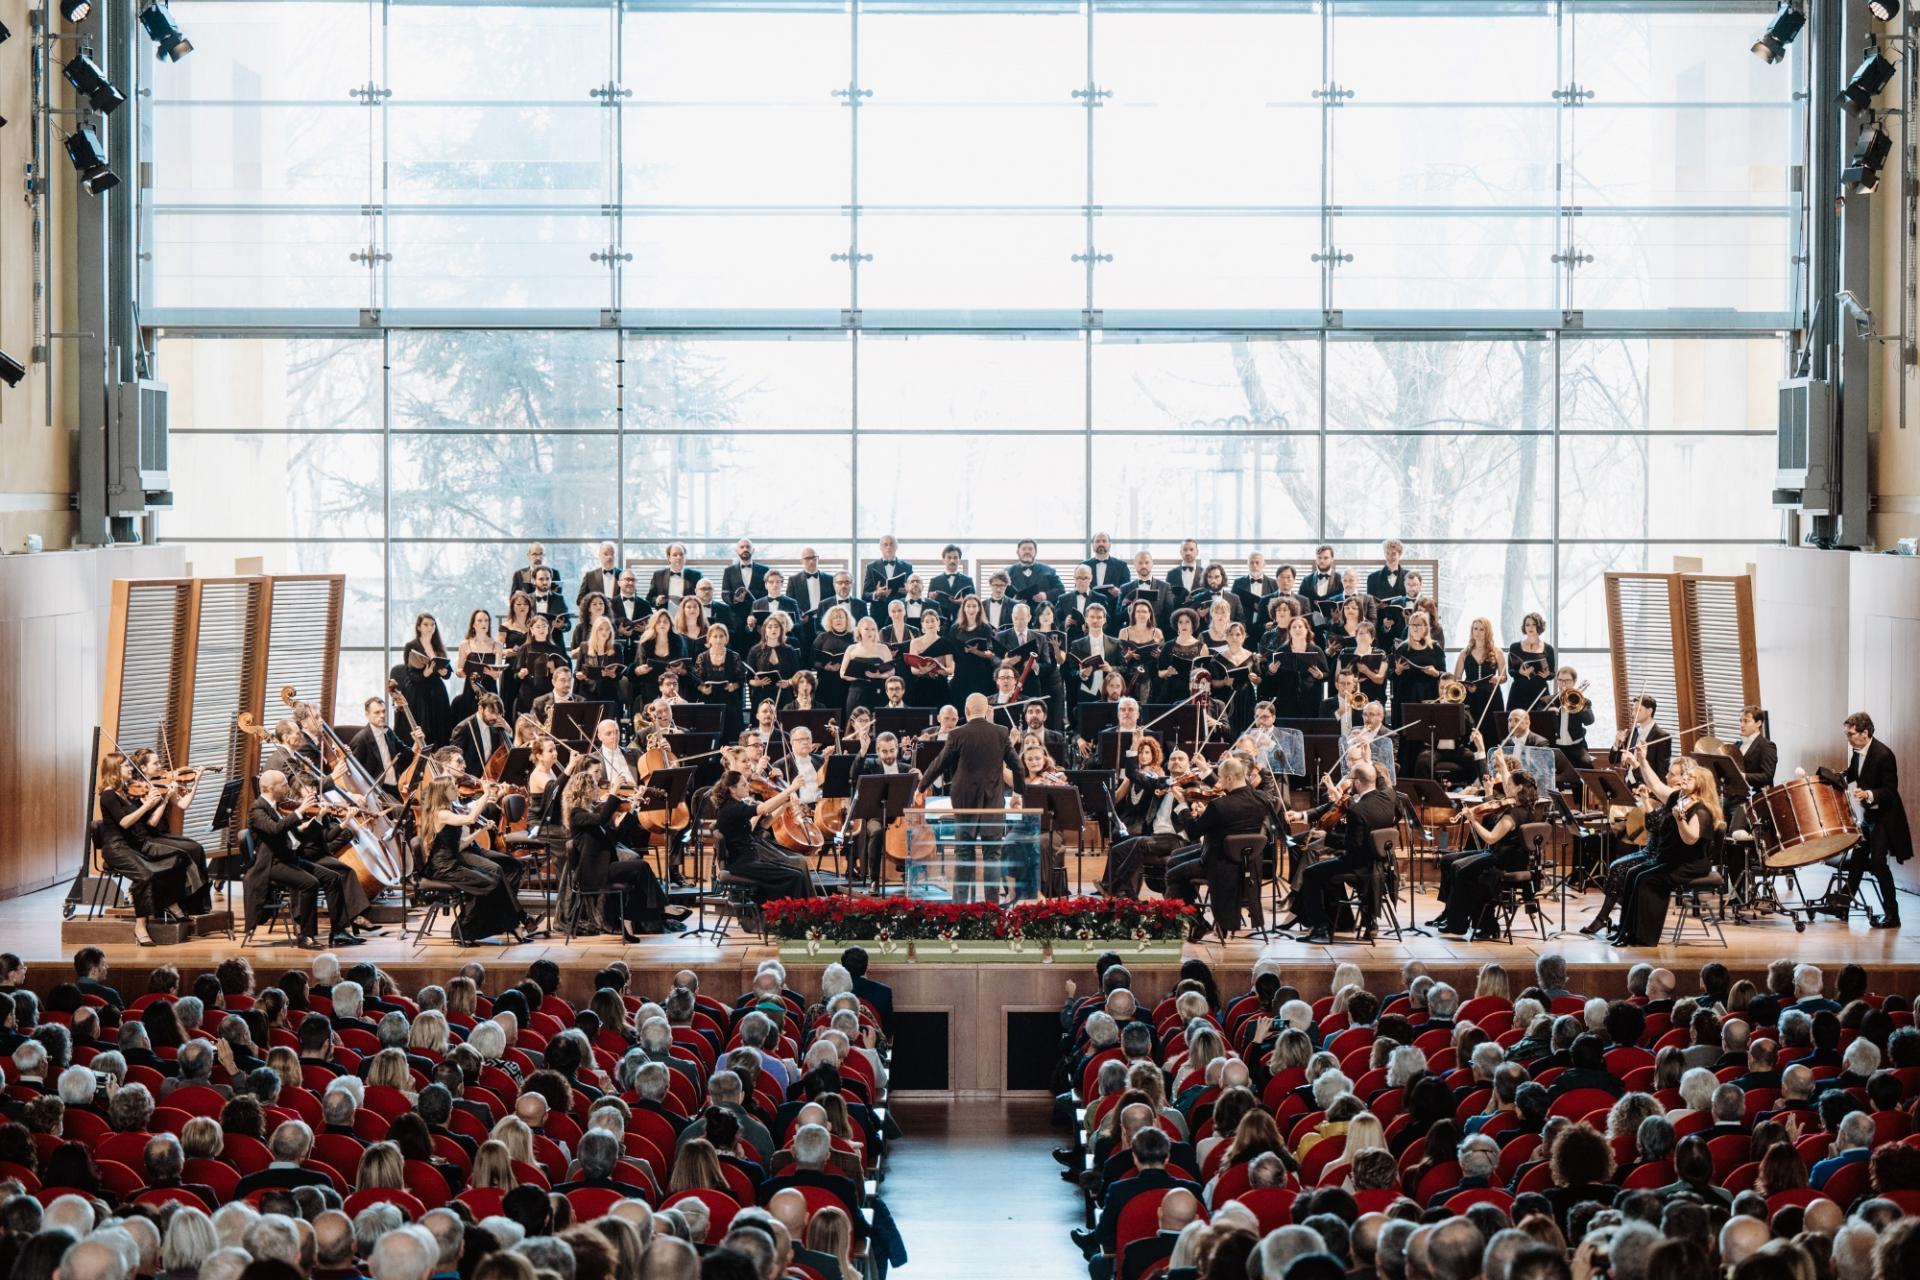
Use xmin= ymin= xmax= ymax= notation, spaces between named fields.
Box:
xmin=94 ymin=750 xmax=209 ymax=946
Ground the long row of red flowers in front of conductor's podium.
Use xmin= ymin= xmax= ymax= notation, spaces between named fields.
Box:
xmin=766 ymin=898 xmax=1194 ymax=954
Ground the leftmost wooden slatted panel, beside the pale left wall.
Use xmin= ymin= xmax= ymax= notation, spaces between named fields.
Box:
xmin=100 ymin=578 xmax=192 ymax=767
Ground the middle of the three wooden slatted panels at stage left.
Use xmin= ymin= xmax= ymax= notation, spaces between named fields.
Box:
xmin=182 ymin=578 xmax=265 ymax=852
